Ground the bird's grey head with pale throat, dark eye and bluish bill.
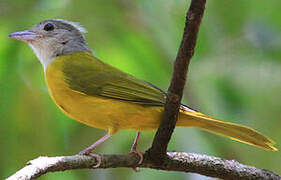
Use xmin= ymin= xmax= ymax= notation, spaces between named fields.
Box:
xmin=9 ymin=19 xmax=90 ymax=69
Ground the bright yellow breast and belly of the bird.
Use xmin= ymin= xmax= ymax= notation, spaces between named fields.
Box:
xmin=46 ymin=70 xmax=163 ymax=133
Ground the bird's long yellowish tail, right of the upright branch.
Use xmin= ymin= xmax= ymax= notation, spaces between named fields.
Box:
xmin=177 ymin=106 xmax=277 ymax=151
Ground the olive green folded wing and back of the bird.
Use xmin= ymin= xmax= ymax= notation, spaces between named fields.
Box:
xmin=63 ymin=52 xmax=166 ymax=106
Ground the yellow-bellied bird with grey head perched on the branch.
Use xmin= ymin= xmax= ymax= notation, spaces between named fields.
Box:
xmin=9 ymin=19 xmax=277 ymax=164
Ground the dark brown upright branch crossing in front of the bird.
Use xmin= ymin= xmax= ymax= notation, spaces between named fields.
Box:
xmin=148 ymin=0 xmax=206 ymax=164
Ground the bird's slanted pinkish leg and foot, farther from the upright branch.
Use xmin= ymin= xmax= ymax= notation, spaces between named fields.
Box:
xmin=79 ymin=133 xmax=112 ymax=168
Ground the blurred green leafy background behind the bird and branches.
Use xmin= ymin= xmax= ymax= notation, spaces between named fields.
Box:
xmin=0 ymin=0 xmax=281 ymax=180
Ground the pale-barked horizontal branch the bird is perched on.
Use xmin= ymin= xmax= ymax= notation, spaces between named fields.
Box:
xmin=7 ymin=152 xmax=281 ymax=180
